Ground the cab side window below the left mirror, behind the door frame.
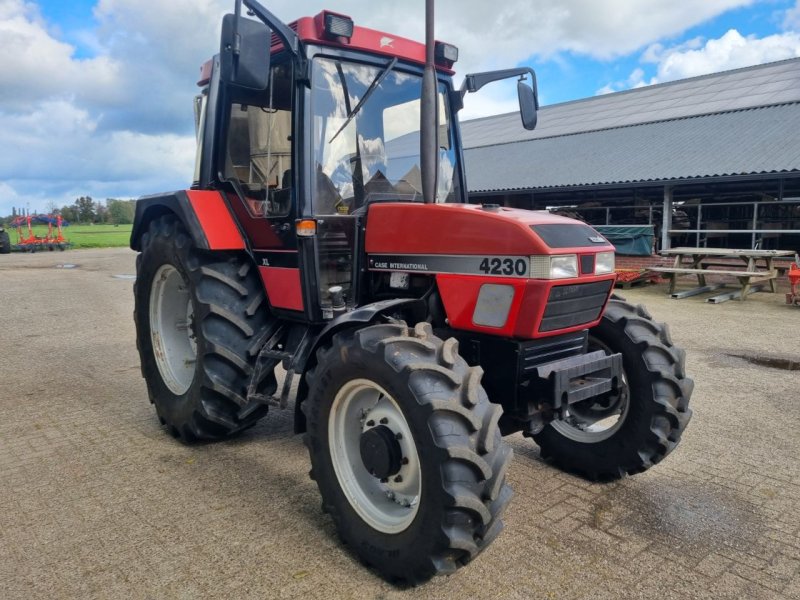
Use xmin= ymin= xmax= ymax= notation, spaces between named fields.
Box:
xmin=225 ymin=63 xmax=293 ymax=217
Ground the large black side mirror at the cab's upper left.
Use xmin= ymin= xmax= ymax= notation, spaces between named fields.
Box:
xmin=219 ymin=15 xmax=272 ymax=91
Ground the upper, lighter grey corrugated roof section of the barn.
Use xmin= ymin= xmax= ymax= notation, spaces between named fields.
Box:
xmin=461 ymin=58 xmax=800 ymax=153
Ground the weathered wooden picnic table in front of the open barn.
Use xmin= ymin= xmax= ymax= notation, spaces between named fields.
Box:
xmin=651 ymin=248 xmax=794 ymax=300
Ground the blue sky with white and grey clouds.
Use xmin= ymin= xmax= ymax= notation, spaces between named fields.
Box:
xmin=0 ymin=0 xmax=800 ymax=217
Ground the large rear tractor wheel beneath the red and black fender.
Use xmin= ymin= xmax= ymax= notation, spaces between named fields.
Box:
xmin=134 ymin=215 xmax=276 ymax=441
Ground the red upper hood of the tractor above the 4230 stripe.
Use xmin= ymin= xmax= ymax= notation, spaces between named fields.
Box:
xmin=366 ymin=202 xmax=614 ymax=256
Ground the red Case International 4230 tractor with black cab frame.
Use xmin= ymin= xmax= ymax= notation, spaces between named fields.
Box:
xmin=131 ymin=0 xmax=692 ymax=583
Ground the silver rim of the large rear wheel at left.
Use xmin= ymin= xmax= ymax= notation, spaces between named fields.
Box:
xmin=150 ymin=264 xmax=197 ymax=396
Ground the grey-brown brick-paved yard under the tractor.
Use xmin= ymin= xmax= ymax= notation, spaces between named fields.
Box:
xmin=0 ymin=249 xmax=800 ymax=599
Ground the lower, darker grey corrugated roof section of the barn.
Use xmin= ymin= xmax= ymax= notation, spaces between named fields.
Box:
xmin=465 ymin=102 xmax=800 ymax=192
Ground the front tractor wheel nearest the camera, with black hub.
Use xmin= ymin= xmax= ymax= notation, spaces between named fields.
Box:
xmin=303 ymin=323 xmax=511 ymax=584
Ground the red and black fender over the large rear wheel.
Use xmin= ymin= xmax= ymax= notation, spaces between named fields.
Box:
xmin=130 ymin=190 xmax=248 ymax=251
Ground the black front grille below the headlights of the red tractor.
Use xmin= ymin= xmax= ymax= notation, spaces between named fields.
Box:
xmin=539 ymin=280 xmax=613 ymax=332
